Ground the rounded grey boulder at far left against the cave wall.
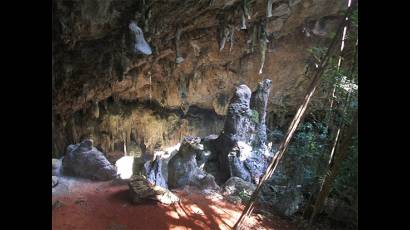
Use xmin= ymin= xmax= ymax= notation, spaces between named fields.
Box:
xmin=62 ymin=139 xmax=117 ymax=180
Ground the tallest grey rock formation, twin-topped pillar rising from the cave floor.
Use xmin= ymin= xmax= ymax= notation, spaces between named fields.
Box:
xmin=210 ymin=79 xmax=272 ymax=183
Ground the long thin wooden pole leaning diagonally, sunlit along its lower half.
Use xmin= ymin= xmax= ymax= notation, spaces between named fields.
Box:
xmin=233 ymin=3 xmax=353 ymax=230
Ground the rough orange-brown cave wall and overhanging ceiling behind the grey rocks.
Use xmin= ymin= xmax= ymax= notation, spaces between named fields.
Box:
xmin=52 ymin=0 xmax=345 ymax=155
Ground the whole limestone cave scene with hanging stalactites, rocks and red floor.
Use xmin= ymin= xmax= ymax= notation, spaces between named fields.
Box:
xmin=52 ymin=0 xmax=358 ymax=230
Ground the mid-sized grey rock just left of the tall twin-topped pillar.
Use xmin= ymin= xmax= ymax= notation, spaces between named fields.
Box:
xmin=168 ymin=137 xmax=219 ymax=190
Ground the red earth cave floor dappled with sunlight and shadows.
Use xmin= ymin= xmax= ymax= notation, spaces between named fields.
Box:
xmin=52 ymin=182 xmax=295 ymax=230
